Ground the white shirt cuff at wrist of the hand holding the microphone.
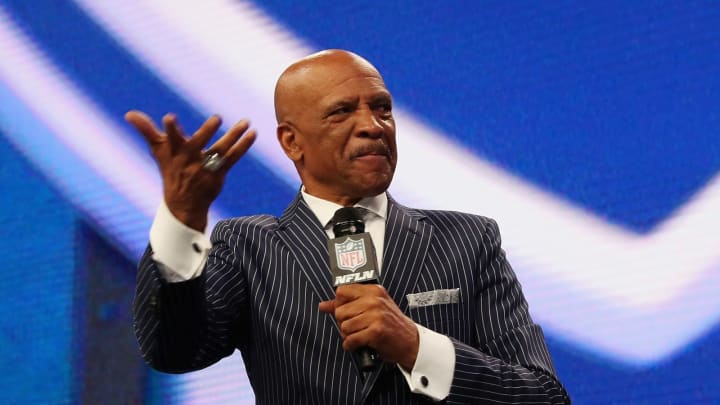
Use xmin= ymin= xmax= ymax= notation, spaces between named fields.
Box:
xmin=398 ymin=324 xmax=455 ymax=401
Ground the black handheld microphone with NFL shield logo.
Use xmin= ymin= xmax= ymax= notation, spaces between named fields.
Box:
xmin=328 ymin=207 xmax=378 ymax=371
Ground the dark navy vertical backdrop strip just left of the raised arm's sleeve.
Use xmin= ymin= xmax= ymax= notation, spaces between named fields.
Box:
xmin=72 ymin=223 xmax=148 ymax=404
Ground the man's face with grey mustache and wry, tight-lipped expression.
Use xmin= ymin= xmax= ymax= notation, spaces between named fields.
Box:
xmin=280 ymin=58 xmax=397 ymax=205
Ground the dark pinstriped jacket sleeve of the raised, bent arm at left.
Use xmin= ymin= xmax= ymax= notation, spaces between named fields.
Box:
xmin=133 ymin=224 xmax=245 ymax=373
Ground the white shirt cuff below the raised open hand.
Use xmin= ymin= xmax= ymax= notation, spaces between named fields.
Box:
xmin=150 ymin=201 xmax=212 ymax=283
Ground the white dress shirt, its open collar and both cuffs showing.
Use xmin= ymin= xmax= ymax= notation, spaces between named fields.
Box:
xmin=150 ymin=192 xmax=455 ymax=401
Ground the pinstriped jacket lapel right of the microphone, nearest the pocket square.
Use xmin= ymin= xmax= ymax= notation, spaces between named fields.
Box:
xmin=362 ymin=196 xmax=432 ymax=402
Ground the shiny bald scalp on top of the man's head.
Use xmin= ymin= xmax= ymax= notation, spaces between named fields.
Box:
xmin=275 ymin=49 xmax=382 ymax=123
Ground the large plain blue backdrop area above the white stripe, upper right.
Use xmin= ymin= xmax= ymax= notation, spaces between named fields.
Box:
xmin=255 ymin=0 xmax=720 ymax=232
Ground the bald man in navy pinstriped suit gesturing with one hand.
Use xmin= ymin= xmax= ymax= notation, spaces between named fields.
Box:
xmin=126 ymin=50 xmax=569 ymax=404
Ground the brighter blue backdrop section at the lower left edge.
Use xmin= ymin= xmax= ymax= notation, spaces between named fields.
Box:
xmin=0 ymin=130 xmax=78 ymax=404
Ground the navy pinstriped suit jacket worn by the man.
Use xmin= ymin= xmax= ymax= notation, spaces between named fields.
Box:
xmin=134 ymin=194 xmax=569 ymax=404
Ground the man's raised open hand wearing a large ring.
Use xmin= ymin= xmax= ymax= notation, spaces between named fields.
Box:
xmin=125 ymin=110 xmax=256 ymax=232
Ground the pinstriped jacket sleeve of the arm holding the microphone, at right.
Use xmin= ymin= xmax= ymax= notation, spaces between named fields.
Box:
xmin=447 ymin=219 xmax=570 ymax=404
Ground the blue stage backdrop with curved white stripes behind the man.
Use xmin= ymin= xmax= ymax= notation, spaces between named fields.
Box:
xmin=0 ymin=0 xmax=720 ymax=404
